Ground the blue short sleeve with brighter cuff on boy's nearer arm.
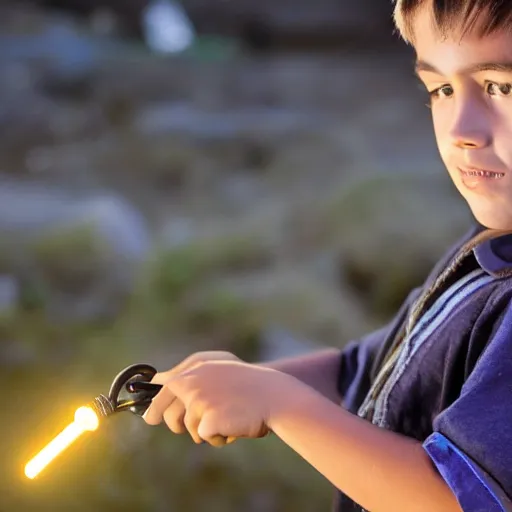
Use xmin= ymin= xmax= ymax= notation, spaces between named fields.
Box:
xmin=423 ymin=303 xmax=512 ymax=512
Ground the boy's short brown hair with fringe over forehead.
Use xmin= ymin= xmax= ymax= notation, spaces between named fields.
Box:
xmin=394 ymin=0 xmax=512 ymax=43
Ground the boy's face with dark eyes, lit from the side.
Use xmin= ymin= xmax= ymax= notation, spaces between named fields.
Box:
xmin=414 ymin=8 xmax=512 ymax=229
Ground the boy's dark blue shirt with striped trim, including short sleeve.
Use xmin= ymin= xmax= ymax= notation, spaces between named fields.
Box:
xmin=336 ymin=226 xmax=512 ymax=512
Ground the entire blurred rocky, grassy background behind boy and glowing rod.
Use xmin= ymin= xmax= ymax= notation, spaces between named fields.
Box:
xmin=0 ymin=0 xmax=470 ymax=512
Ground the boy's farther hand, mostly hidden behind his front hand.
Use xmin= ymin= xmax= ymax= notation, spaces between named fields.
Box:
xmin=144 ymin=350 xmax=241 ymax=440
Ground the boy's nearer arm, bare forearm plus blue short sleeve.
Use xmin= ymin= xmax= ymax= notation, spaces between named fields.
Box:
xmin=269 ymin=295 xmax=512 ymax=512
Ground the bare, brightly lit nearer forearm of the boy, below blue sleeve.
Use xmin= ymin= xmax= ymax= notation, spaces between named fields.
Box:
xmin=269 ymin=388 xmax=461 ymax=512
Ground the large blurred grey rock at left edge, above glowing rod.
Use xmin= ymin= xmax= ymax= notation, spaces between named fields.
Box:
xmin=0 ymin=182 xmax=151 ymax=319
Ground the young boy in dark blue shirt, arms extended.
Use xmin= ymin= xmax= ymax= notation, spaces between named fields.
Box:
xmin=145 ymin=0 xmax=512 ymax=512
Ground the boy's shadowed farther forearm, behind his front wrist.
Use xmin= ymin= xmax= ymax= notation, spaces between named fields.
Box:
xmin=261 ymin=348 xmax=341 ymax=403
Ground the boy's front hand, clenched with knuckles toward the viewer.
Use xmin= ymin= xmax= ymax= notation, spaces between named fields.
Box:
xmin=144 ymin=361 xmax=300 ymax=446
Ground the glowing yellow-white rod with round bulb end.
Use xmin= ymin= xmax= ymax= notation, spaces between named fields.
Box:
xmin=25 ymin=407 xmax=99 ymax=479
